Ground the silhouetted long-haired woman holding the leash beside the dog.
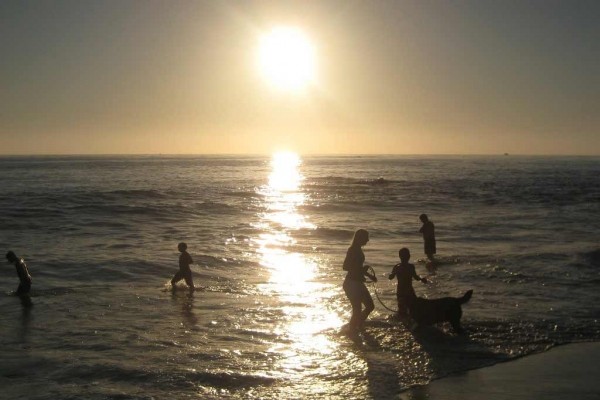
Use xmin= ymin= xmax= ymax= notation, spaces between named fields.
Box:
xmin=343 ymin=229 xmax=377 ymax=334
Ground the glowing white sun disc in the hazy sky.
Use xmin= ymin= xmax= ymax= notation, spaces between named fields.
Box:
xmin=258 ymin=27 xmax=316 ymax=92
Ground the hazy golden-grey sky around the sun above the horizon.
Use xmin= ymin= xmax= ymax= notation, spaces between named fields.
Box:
xmin=0 ymin=0 xmax=600 ymax=155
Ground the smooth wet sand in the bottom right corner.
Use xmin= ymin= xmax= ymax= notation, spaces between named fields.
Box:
xmin=399 ymin=342 xmax=600 ymax=400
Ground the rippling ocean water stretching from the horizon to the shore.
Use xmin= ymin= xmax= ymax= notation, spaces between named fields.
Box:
xmin=0 ymin=153 xmax=600 ymax=400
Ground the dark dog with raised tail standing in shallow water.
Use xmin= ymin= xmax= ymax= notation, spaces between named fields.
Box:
xmin=408 ymin=290 xmax=473 ymax=333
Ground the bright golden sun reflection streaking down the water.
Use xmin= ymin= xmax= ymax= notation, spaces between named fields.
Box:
xmin=255 ymin=153 xmax=342 ymax=374
